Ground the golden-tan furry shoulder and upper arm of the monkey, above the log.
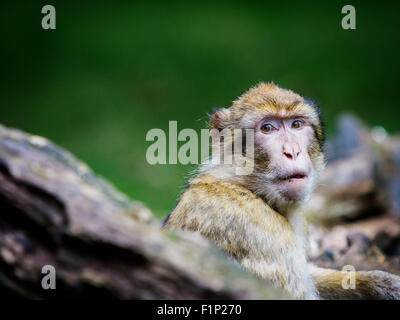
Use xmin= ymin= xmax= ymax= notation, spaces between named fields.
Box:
xmin=165 ymin=175 xmax=315 ymax=299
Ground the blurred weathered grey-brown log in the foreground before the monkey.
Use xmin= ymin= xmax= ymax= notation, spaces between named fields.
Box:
xmin=0 ymin=125 xmax=283 ymax=299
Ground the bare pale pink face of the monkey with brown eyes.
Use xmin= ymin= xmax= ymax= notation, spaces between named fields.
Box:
xmin=254 ymin=115 xmax=315 ymax=202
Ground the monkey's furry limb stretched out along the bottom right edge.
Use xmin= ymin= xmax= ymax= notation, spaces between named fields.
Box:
xmin=310 ymin=266 xmax=400 ymax=300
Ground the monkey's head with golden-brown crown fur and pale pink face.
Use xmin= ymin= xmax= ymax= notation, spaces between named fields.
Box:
xmin=210 ymin=83 xmax=324 ymax=213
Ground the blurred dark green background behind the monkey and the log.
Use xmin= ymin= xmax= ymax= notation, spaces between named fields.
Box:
xmin=0 ymin=1 xmax=400 ymax=217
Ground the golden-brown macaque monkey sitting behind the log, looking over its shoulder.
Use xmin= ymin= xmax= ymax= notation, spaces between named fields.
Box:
xmin=163 ymin=82 xmax=400 ymax=299
